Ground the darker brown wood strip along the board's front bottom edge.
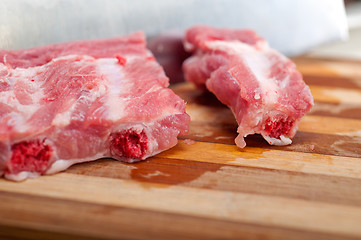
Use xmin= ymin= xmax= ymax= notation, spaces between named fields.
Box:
xmin=0 ymin=192 xmax=346 ymax=240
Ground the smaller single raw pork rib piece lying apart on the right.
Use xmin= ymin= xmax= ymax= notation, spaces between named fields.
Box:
xmin=183 ymin=26 xmax=313 ymax=148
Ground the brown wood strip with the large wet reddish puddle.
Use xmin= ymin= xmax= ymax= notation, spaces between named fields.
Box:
xmin=66 ymin=157 xmax=361 ymax=206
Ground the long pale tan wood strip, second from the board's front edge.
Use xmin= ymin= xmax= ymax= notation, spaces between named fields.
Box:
xmin=0 ymin=173 xmax=361 ymax=237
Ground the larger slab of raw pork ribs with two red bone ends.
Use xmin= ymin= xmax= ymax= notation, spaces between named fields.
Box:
xmin=0 ymin=33 xmax=190 ymax=180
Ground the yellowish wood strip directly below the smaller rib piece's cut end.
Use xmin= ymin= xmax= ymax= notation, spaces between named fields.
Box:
xmin=159 ymin=141 xmax=361 ymax=178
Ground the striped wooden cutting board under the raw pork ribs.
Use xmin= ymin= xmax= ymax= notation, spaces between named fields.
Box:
xmin=0 ymin=58 xmax=361 ymax=239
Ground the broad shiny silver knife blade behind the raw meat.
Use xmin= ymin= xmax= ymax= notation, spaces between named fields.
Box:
xmin=0 ymin=0 xmax=347 ymax=55
